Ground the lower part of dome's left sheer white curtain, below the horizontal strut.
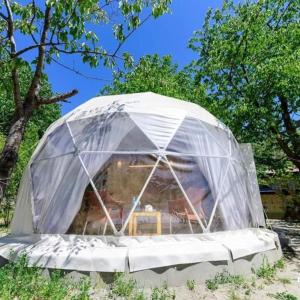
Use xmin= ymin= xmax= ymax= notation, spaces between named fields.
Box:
xmin=30 ymin=154 xmax=89 ymax=233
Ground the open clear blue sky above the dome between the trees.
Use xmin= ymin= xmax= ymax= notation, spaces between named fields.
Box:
xmin=41 ymin=0 xmax=222 ymax=114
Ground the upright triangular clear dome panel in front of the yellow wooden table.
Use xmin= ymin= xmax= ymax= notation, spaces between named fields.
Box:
xmin=125 ymin=158 xmax=202 ymax=236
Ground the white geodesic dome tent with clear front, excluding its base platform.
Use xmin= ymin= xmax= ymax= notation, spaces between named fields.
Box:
xmin=12 ymin=93 xmax=264 ymax=236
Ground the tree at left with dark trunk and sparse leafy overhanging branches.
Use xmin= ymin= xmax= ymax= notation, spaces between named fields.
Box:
xmin=0 ymin=0 xmax=171 ymax=201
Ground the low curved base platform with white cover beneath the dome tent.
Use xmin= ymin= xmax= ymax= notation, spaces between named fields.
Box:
xmin=0 ymin=228 xmax=282 ymax=287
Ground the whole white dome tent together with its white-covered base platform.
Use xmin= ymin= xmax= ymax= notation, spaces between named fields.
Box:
xmin=0 ymin=93 xmax=280 ymax=282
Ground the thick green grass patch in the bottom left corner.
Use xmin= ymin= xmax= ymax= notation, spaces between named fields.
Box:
xmin=0 ymin=254 xmax=90 ymax=300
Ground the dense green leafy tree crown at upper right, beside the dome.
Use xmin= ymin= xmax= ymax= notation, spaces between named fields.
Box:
xmin=189 ymin=0 xmax=300 ymax=168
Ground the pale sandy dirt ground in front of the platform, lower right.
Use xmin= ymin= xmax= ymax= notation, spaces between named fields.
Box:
xmin=95 ymin=258 xmax=300 ymax=300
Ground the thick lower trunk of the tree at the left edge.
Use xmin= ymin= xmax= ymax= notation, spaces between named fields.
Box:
xmin=0 ymin=115 xmax=28 ymax=204
